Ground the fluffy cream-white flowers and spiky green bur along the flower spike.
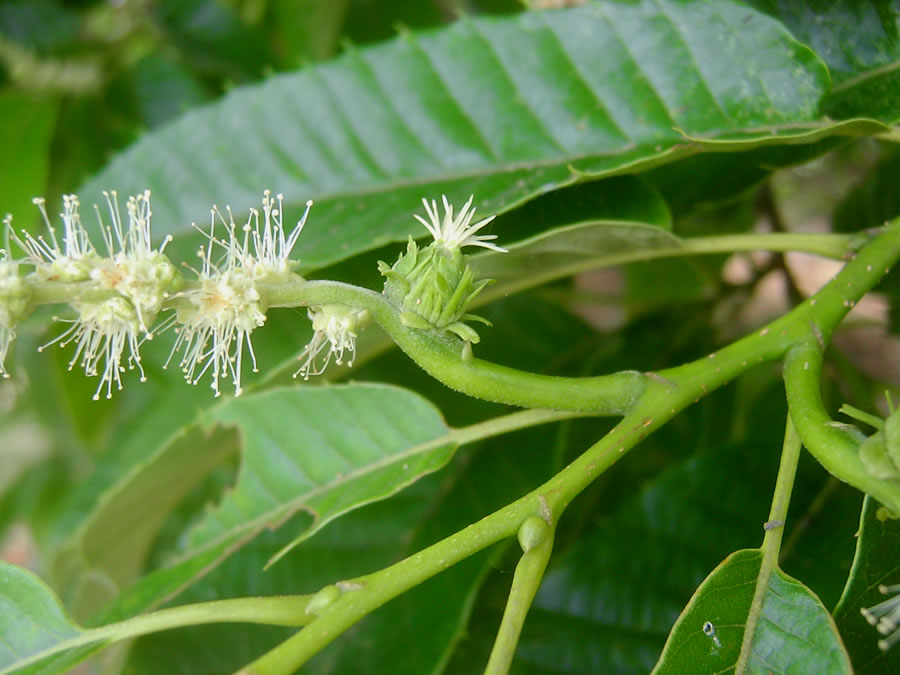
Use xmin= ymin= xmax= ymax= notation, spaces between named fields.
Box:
xmin=0 ymin=190 xmax=505 ymax=399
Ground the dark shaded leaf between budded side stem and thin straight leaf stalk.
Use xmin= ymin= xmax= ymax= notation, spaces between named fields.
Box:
xmin=478 ymin=440 xmax=777 ymax=673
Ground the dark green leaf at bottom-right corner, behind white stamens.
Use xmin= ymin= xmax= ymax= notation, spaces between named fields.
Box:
xmin=834 ymin=496 xmax=900 ymax=675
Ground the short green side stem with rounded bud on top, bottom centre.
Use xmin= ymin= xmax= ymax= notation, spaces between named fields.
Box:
xmin=484 ymin=516 xmax=555 ymax=675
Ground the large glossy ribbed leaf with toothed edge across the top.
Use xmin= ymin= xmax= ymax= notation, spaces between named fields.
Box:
xmin=74 ymin=0 xmax=840 ymax=269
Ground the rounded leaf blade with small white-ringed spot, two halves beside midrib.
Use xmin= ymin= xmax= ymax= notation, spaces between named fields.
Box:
xmin=653 ymin=549 xmax=852 ymax=675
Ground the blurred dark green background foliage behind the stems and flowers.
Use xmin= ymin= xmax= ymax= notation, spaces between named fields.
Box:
xmin=0 ymin=0 xmax=900 ymax=675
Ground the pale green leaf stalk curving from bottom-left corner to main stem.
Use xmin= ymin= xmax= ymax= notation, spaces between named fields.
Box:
xmin=0 ymin=595 xmax=315 ymax=675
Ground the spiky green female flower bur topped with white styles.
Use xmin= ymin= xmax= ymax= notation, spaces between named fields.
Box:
xmin=378 ymin=196 xmax=506 ymax=343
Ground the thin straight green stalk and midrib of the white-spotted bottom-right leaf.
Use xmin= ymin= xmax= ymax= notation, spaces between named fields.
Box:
xmin=734 ymin=414 xmax=802 ymax=675
